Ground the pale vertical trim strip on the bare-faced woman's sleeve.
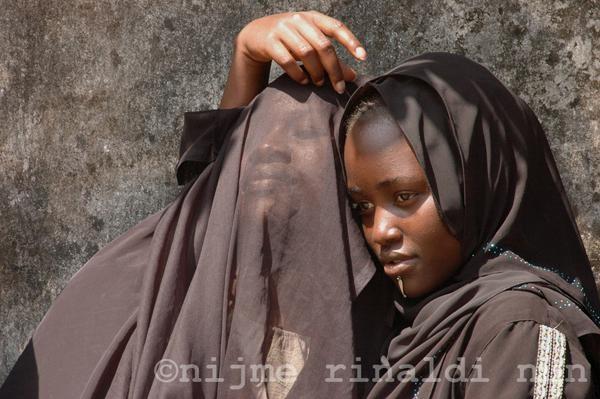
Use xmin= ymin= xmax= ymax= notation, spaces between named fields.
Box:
xmin=533 ymin=325 xmax=567 ymax=399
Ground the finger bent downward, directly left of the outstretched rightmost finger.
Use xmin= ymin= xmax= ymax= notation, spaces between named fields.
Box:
xmin=296 ymin=19 xmax=346 ymax=94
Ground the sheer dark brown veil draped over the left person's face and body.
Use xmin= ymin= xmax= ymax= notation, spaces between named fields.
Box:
xmin=0 ymin=76 xmax=391 ymax=399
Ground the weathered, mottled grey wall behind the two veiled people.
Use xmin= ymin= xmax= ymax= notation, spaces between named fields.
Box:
xmin=0 ymin=0 xmax=600 ymax=381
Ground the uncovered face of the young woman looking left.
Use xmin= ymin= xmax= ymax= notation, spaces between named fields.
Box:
xmin=344 ymin=111 xmax=461 ymax=297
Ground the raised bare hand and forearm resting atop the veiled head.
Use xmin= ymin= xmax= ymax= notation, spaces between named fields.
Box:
xmin=219 ymin=11 xmax=366 ymax=108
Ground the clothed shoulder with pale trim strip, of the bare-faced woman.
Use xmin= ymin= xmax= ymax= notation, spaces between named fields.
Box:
xmin=463 ymin=289 xmax=593 ymax=398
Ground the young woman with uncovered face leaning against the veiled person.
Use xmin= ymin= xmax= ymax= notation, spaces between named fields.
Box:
xmin=340 ymin=53 xmax=600 ymax=398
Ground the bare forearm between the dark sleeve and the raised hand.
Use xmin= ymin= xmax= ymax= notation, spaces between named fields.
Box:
xmin=219 ymin=39 xmax=271 ymax=108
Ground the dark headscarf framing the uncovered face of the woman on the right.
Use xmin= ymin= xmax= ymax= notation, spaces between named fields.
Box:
xmin=340 ymin=53 xmax=600 ymax=397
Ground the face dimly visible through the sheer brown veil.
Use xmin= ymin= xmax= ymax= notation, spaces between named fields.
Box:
xmin=242 ymin=93 xmax=330 ymax=221
